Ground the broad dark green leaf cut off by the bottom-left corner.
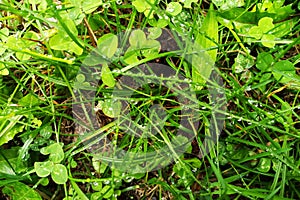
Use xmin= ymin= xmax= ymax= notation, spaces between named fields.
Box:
xmin=2 ymin=182 xmax=42 ymax=200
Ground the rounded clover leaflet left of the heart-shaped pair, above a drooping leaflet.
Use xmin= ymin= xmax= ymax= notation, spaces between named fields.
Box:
xmin=96 ymin=33 xmax=118 ymax=58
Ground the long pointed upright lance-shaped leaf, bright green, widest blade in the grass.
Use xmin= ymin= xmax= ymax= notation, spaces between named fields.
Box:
xmin=192 ymin=5 xmax=219 ymax=89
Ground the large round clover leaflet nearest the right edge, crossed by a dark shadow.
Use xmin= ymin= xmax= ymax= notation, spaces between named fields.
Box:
xmin=272 ymin=60 xmax=296 ymax=83
